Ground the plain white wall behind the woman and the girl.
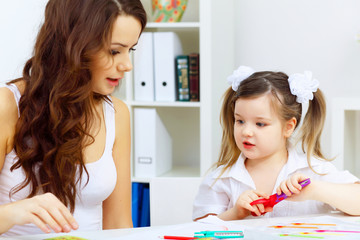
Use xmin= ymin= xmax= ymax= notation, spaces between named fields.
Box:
xmin=0 ymin=0 xmax=360 ymax=167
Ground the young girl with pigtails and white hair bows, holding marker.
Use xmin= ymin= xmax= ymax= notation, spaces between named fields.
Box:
xmin=193 ymin=66 xmax=360 ymax=220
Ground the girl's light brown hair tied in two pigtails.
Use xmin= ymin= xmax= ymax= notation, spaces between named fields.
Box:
xmin=216 ymin=71 xmax=328 ymax=173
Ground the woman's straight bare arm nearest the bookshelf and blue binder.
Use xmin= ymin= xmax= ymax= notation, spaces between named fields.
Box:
xmin=103 ymin=97 xmax=133 ymax=229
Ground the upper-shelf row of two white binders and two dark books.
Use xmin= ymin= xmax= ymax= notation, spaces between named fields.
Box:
xmin=134 ymin=32 xmax=200 ymax=102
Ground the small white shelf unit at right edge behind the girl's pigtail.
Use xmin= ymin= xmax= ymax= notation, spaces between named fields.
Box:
xmin=331 ymin=98 xmax=360 ymax=177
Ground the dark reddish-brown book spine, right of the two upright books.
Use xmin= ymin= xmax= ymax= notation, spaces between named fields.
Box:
xmin=189 ymin=53 xmax=200 ymax=102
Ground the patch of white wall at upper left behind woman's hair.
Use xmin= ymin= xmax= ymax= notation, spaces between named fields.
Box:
xmin=0 ymin=0 xmax=47 ymax=82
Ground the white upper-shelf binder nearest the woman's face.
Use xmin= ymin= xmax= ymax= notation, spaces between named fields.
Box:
xmin=134 ymin=32 xmax=155 ymax=101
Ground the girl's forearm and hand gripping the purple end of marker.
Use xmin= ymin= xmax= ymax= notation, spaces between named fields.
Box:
xmin=277 ymin=173 xmax=360 ymax=215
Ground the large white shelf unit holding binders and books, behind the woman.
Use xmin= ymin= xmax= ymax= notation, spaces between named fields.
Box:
xmin=114 ymin=0 xmax=235 ymax=182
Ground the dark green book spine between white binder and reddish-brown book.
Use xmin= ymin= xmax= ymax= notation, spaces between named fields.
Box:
xmin=175 ymin=55 xmax=190 ymax=101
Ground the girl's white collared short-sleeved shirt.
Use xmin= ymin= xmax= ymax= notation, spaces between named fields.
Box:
xmin=192 ymin=148 xmax=359 ymax=219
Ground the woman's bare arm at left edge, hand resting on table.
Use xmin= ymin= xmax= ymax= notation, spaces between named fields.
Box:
xmin=0 ymin=88 xmax=78 ymax=234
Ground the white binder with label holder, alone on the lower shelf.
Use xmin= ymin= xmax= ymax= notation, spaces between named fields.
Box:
xmin=134 ymin=108 xmax=172 ymax=178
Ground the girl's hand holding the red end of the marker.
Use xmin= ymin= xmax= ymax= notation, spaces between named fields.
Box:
xmin=235 ymin=190 xmax=272 ymax=216
